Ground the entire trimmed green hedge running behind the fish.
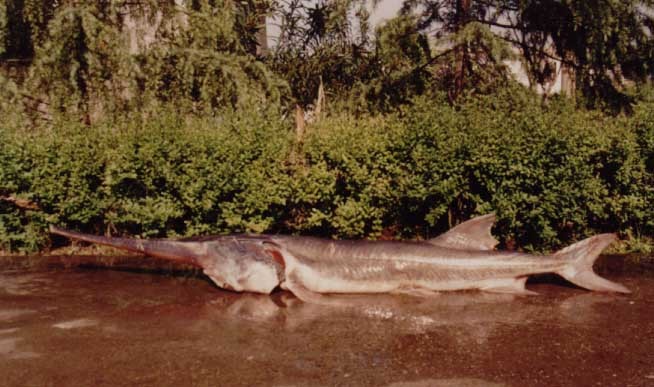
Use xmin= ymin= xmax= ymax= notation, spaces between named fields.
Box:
xmin=0 ymin=96 xmax=654 ymax=251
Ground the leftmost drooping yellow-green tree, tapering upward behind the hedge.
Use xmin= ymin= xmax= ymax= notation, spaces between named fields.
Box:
xmin=26 ymin=4 xmax=132 ymax=122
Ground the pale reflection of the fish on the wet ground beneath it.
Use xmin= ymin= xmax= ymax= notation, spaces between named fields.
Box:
xmin=188 ymin=292 xmax=615 ymax=344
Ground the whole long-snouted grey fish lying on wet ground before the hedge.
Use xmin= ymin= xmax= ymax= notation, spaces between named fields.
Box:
xmin=50 ymin=214 xmax=629 ymax=302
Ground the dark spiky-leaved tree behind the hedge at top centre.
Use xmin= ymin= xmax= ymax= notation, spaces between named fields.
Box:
xmin=270 ymin=0 xmax=370 ymax=106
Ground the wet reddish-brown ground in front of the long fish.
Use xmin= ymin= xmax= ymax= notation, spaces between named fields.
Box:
xmin=0 ymin=258 xmax=654 ymax=387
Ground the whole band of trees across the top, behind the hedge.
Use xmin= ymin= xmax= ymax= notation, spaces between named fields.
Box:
xmin=5 ymin=0 xmax=654 ymax=115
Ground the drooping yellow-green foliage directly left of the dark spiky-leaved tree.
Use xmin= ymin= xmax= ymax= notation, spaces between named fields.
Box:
xmin=142 ymin=1 xmax=285 ymax=111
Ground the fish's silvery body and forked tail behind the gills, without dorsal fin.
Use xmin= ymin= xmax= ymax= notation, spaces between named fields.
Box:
xmin=272 ymin=234 xmax=629 ymax=299
